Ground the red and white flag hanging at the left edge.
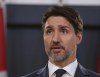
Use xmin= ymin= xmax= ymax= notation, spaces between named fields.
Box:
xmin=0 ymin=3 xmax=7 ymax=77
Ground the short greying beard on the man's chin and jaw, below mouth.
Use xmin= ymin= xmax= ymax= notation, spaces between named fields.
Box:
xmin=46 ymin=51 xmax=73 ymax=62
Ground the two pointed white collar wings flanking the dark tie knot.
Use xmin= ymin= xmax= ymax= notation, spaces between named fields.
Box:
xmin=48 ymin=59 xmax=78 ymax=77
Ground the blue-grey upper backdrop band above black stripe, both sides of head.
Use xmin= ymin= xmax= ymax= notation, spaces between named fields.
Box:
xmin=7 ymin=5 xmax=100 ymax=26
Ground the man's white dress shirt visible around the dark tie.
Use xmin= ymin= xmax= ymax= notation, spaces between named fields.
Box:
xmin=48 ymin=60 xmax=78 ymax=77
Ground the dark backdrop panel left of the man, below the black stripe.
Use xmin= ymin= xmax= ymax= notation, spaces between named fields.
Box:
xmin=8 ymin=29 xmax=47 ymax=77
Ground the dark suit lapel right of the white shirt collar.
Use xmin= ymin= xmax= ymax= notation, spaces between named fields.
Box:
xmin=75 ymin=64 xmax=89 ymax=77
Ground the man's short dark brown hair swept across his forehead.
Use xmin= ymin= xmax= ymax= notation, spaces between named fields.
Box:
xmin=42 ymin=6 xmax=83 ymax=34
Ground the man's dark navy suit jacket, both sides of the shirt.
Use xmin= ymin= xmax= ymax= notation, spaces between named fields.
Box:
xmin=21 ymin=64 xmax=100 ymax=77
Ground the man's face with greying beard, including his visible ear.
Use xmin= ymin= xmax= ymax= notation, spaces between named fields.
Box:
xmin=44 ymin=16 xmax=82 ymax=61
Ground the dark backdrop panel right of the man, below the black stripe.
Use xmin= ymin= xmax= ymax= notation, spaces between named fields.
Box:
xmin=77 ymin=29 xmax=100 ymax=69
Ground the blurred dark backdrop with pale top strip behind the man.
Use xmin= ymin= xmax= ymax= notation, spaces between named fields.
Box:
xmin=0 ymin=0 xmax=100 ymax=77
